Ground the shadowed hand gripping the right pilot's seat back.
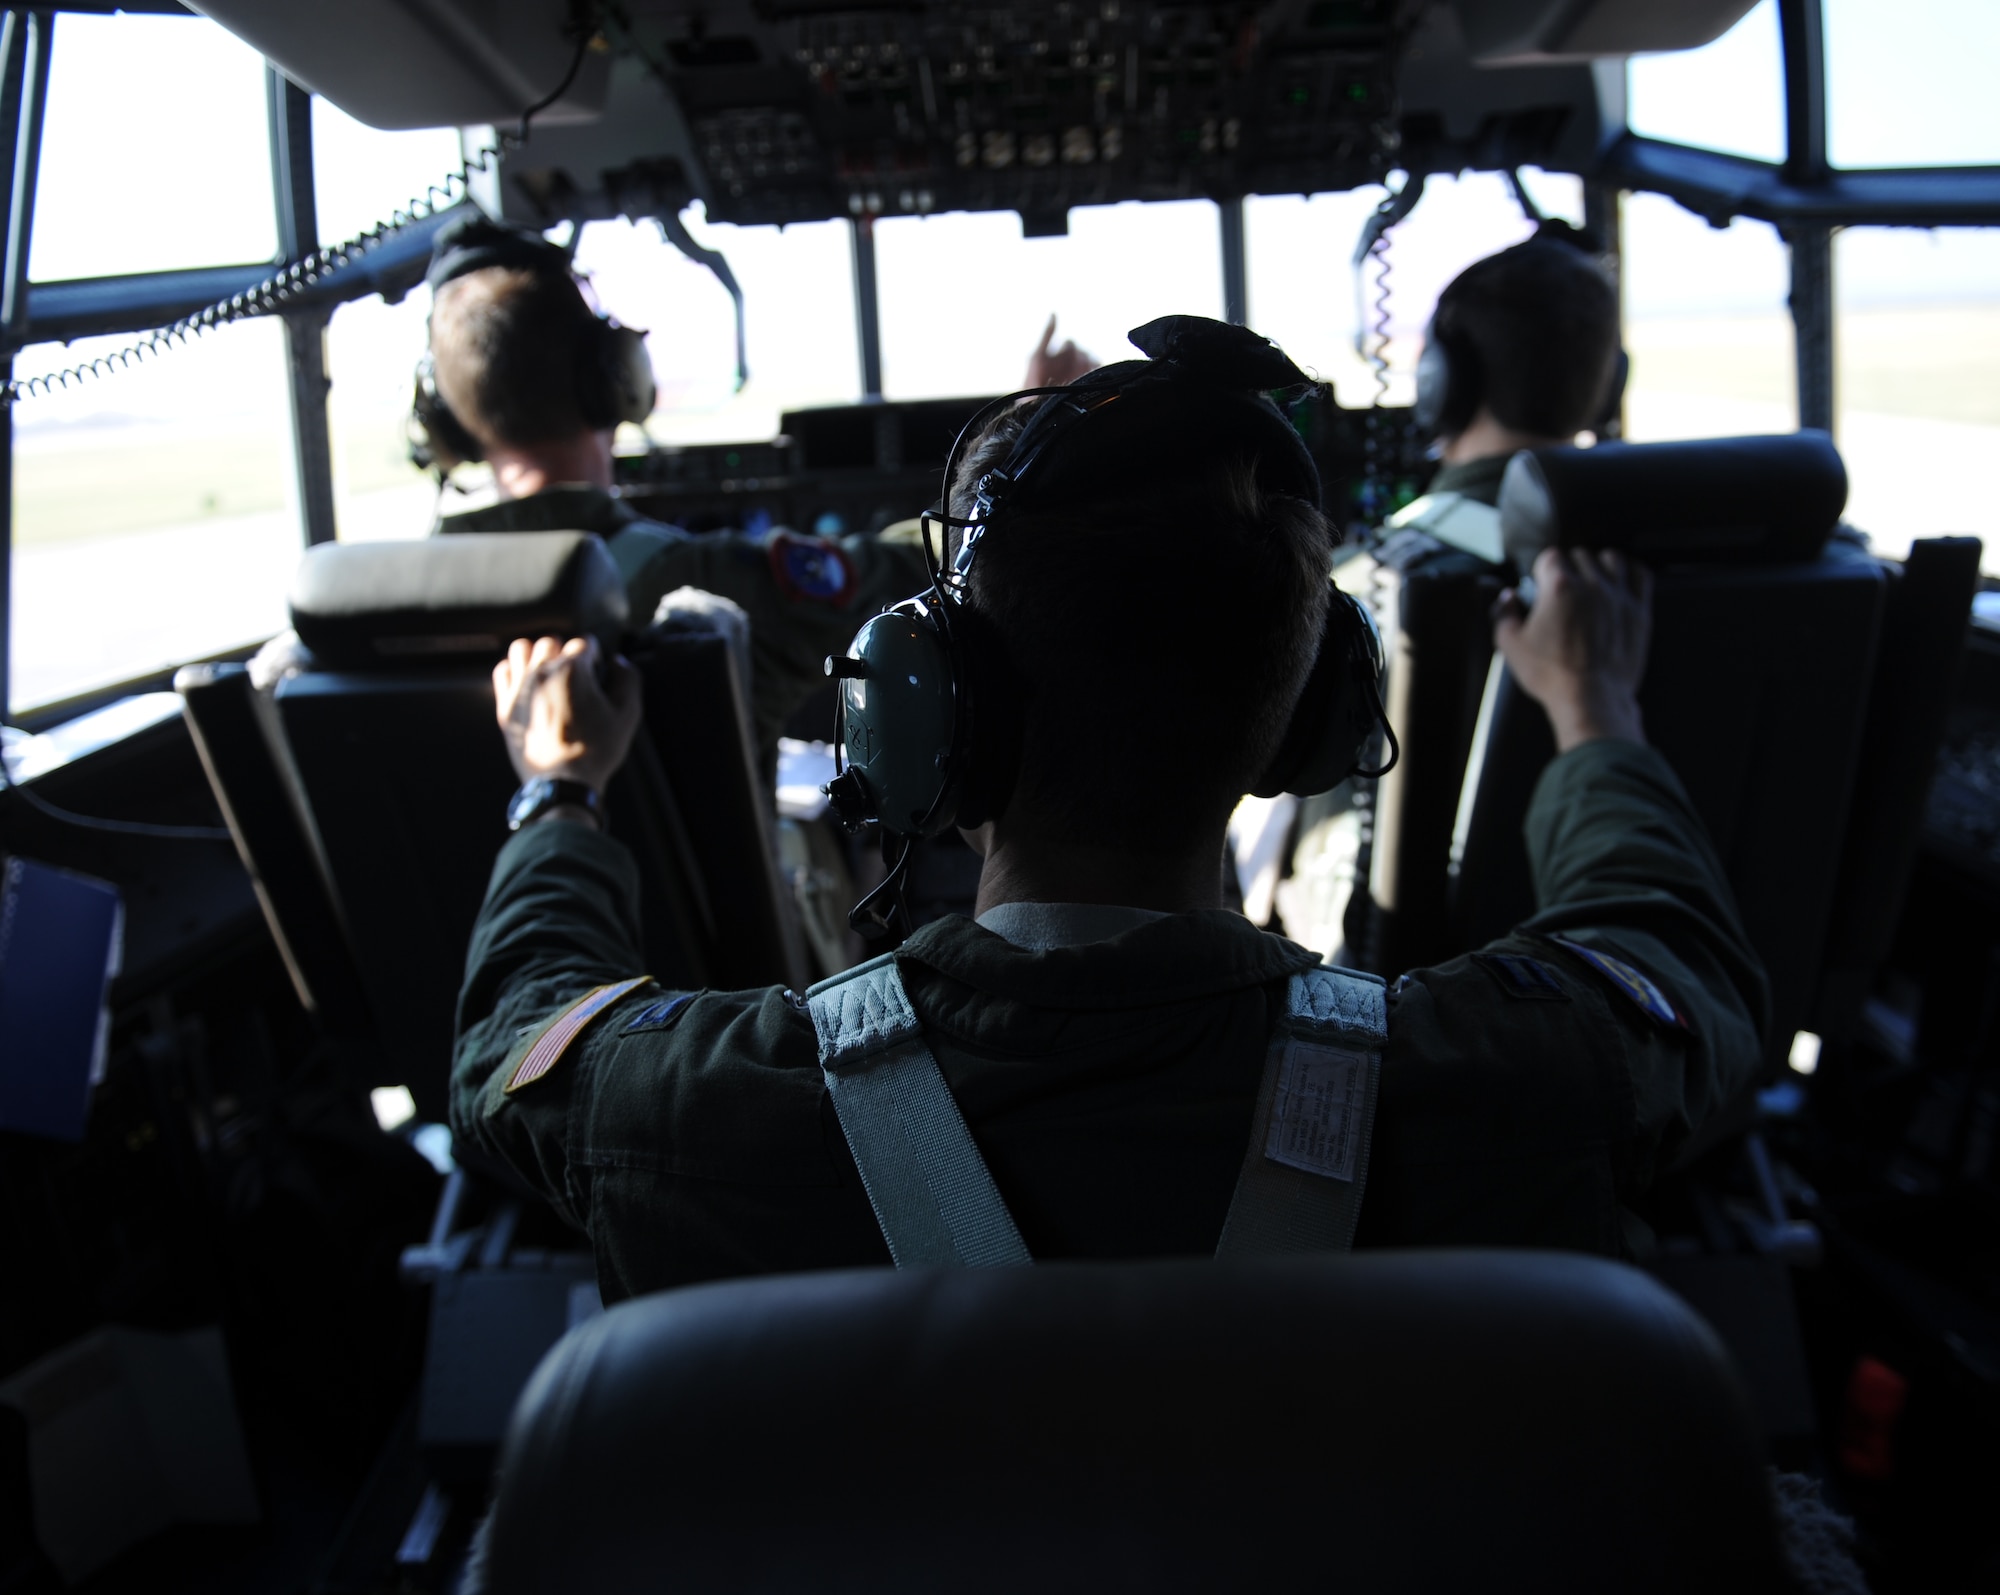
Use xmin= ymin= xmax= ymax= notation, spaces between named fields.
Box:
xmin=1494 ymin=548 xmax=1652 ymax=754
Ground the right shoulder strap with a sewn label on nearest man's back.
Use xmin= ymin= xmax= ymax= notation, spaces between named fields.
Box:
xmin=1216 ymin=969 xmax=1388 ymax=1259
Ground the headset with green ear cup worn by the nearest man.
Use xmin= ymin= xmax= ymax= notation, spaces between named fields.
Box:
xmin=826 ymin=316 xmax=1396 ymax=935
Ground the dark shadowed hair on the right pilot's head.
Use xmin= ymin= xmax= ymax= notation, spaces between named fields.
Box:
xmin=1434 ymin=224 xmax=1618 ymax=438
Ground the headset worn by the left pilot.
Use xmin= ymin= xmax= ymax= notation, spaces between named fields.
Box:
xmin=410 ymin=212 xmax=658 ymax=480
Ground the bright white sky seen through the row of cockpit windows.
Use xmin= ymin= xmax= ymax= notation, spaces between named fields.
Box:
xmin=20 ymin=0 xmax=2000 ymax=440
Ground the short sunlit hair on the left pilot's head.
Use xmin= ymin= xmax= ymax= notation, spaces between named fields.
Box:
xmin=430 ymin=266 xmax=590 ymax=448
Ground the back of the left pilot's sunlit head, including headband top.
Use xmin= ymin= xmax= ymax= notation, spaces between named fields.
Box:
xmin=430 ymin=218 xmax=594 ymax=450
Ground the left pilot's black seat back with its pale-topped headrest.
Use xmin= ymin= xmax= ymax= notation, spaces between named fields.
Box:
xmin=184 ymin=532 xmax=800 ymax=1117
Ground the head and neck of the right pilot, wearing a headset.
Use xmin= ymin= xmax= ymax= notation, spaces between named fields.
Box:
xmin=1416 ymin=222 xmax=1624 ymax=535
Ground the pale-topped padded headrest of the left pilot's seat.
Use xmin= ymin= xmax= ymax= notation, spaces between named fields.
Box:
xmin=292 ymin=532 xmax=626 ymax=668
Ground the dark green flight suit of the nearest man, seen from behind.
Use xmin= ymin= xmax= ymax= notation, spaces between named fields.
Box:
xmin=452 ymin=742 xmax=1766 ymax=1301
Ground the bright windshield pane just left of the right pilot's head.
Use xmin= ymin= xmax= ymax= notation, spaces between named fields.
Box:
xmin=1244 ymin=170 xmax=1584 ymax=410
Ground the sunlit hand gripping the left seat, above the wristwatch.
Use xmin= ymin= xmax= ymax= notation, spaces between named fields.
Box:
xmin=494 ymin=638 xmax=640 ymax=792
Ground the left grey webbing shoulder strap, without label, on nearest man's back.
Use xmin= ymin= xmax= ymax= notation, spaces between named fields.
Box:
xmin=806 ymin=953 xmax=1032 ymax=1269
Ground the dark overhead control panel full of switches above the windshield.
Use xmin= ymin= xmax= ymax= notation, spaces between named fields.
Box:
xmin=668 ymin=0 xmax=1408 ymax=232
